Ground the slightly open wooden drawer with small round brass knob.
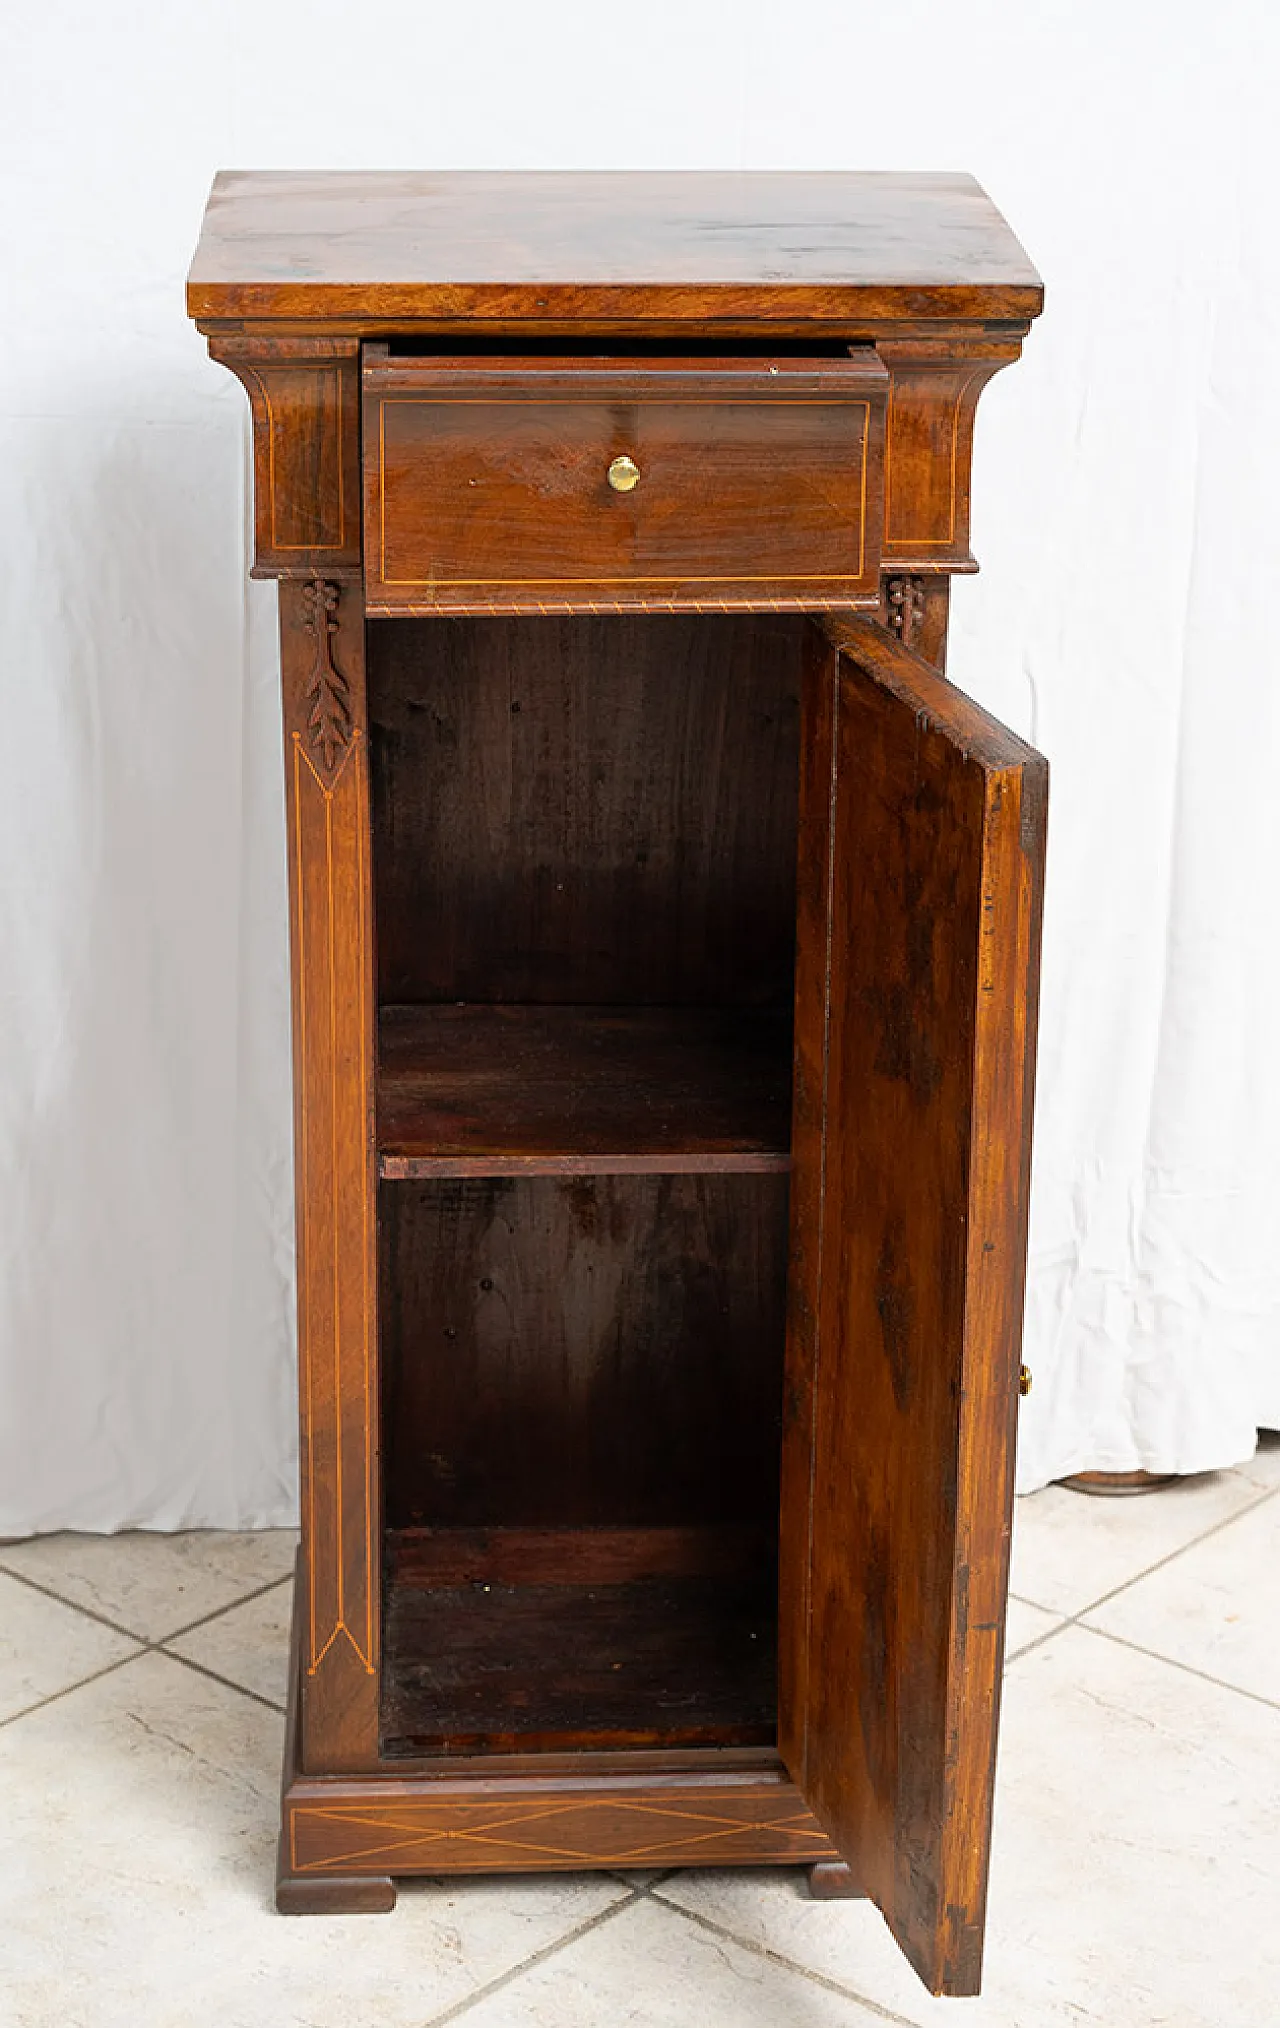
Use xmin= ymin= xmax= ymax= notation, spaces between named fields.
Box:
xmin=363 ymin=347 xmax=888 ymax=614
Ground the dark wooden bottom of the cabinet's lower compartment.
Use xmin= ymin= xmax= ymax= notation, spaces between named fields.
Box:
xmin=381 ymin=1527 xmax=777 ymax=1760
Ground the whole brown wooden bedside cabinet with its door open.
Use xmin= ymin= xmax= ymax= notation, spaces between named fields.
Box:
xmin=189 ymin=174 xmax=1047 ymax=1994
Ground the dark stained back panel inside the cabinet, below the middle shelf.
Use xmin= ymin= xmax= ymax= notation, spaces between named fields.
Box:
xmin=379 ymin=1174 xmax=787 ymax=1531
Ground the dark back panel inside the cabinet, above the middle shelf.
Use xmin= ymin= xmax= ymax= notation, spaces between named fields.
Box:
xmin=367 ymin=614 xmax=809 ymax=1006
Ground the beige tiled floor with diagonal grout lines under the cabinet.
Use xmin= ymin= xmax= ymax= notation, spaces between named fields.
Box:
xmin=0 ymin=1440 xmax=1280 ymax=2028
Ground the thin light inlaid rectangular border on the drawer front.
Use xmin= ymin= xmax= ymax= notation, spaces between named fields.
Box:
xmin=377 ymin=391 xmax=870 ymax=590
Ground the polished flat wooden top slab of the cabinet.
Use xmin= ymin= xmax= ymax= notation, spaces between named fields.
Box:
xmin=187 ymin=170 xmax=1043 ymax=329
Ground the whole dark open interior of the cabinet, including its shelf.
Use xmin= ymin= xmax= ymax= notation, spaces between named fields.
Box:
xmin=367 ymin=614 xmax=811 ymax=1758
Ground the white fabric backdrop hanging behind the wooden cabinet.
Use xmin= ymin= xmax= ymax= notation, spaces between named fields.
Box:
xmin=0 ymin=0 xmax=1280 ymax=1533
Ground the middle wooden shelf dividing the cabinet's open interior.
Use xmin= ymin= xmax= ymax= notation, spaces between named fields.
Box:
xmin=377 ymin=1006 xmax=791 ymax=1178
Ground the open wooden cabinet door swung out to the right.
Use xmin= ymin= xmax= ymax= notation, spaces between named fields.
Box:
xmin=779 ymin=619 xmax=1049 ymax=1996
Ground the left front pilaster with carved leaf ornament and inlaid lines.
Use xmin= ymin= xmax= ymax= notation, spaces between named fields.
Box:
xmin=280 ymin=580 xmax=379 ymax=1772
